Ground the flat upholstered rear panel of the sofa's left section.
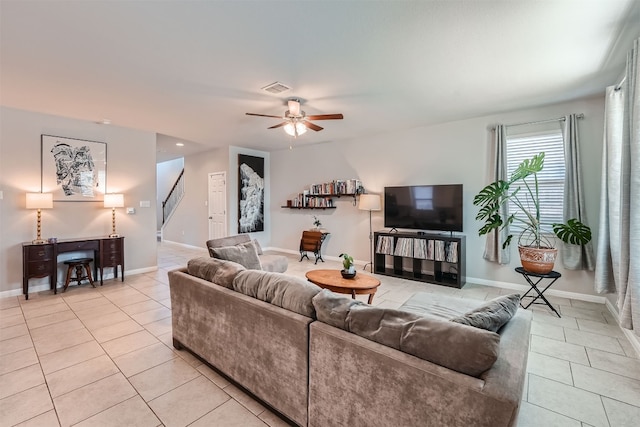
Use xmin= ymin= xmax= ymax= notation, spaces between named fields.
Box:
xmin=169 ymin=269 xmax=313 ymax=425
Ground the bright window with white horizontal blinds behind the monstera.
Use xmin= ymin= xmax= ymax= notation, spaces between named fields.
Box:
xmin=507 ymin=130 xmax=565 ymax=231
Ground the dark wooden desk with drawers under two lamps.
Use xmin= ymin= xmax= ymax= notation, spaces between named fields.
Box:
xmin=22 ymin=236 xmax=124 ymax=299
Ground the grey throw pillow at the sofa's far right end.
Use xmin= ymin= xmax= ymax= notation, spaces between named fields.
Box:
xmin=451 ymin=294 xmax=520 ymax=332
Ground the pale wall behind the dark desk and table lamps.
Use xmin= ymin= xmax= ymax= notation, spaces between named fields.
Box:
xmin=0 ymin=107 xmax=157 ymax=292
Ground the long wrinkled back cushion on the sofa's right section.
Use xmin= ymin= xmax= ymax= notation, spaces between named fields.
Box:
xmin=313 ymin=290 xmax=500 ymax=377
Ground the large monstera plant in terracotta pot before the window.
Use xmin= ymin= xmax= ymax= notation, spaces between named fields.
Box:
xmin=473 ymin=152 xmax=591 ymax=274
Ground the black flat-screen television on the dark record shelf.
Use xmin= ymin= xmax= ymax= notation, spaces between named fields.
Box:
xmin=384 ymin=184 xmax=462 ymax=231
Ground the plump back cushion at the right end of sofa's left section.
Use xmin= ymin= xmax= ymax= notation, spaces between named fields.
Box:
xmin=233 ymin=270 xmax=320 ymax=319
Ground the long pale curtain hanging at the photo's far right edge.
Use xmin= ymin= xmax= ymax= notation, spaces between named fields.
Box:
xmin=595 ymin=39 xmax=640 ymax=335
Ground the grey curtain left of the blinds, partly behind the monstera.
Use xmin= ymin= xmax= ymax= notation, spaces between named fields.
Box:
xmin=482 ymin=125 xmax=509 ymax=264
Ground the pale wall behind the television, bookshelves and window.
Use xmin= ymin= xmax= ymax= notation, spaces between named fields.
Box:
xmin=271 ymin=97 xmax=604 ymax=294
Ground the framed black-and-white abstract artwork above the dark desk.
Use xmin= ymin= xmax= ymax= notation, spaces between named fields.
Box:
xmin=40 ymin=135 xmax=107 ymax=202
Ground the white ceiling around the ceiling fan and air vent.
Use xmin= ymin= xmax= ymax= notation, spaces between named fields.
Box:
xmin=0 ymin=0 xmax=640 ymax=159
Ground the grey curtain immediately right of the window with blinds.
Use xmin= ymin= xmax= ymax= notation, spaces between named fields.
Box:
xmin=560 ymin=114 xmax=595 ymax=271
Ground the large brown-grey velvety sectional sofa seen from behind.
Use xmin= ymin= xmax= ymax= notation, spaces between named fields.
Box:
xmin=169 ymin=257 xmax=531 ymax=427
